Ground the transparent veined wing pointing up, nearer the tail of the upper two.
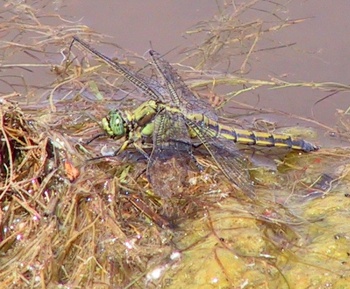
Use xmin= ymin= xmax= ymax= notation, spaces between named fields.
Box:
xmin=149 ymin=50 xmax=218 ymax=121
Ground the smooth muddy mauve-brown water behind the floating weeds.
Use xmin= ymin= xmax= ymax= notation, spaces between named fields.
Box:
xmin=0 ymin=0 xmax=350 ymax=141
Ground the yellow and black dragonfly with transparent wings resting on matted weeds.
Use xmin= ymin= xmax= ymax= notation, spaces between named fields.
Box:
xmin=73 ymin=37 xmax=319 ymax=194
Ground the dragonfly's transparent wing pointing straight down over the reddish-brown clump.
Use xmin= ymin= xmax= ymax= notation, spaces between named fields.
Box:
xmin=147 ymin=109 xmax=194 ymax=197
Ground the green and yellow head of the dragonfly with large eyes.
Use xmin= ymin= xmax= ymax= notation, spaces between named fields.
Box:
xmin=102 ymin=110 xmax=126 ymax=139
